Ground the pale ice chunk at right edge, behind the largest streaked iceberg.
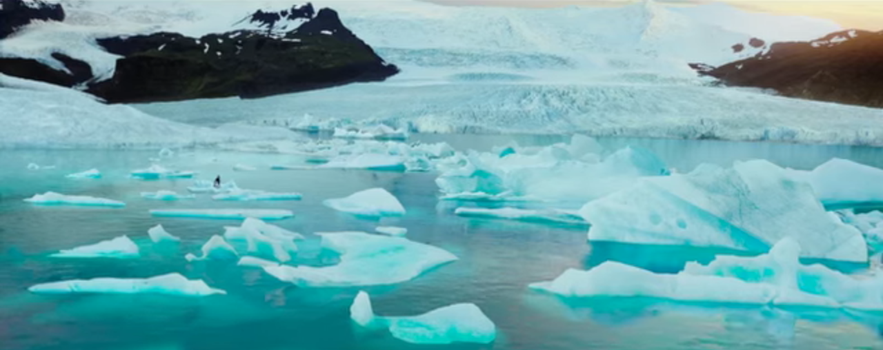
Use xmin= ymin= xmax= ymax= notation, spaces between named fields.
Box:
xmin=795 ymin=158 xmax=883 ymax=207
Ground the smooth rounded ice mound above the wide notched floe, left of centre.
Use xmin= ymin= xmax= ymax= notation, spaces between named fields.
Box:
xmin=322 ymin=188 xmax=405 ymax=216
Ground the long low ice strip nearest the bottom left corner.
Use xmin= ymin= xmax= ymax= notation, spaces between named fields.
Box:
xmin=28 ymin=273 xmax=227 ymax=296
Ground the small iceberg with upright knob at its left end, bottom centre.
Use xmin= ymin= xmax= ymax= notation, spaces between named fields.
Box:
xmin=350 ymin=291 xmax=497 ymax=344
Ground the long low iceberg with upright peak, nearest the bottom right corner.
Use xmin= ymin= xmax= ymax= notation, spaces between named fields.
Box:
xmin=531 ymin=237 xmax=883 ymax=310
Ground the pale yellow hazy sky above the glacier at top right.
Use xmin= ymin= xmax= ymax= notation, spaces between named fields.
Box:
xmin=430 ymin=0 xmax=883 ymax=30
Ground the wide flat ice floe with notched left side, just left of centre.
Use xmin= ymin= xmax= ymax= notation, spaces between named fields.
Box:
xmin=264 ymin=232 xmax=457 ymax=287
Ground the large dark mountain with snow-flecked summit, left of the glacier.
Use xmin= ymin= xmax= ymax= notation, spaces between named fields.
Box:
xmin=0 ymin=0 xmax=399 ymax=103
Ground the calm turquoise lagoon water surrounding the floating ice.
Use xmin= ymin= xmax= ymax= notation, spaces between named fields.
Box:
xmin=0 ymin=135 xmax=883 ymax=350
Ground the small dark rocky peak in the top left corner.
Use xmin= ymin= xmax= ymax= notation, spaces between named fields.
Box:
xmin=0 ymin=0 xmax=64 ymax=39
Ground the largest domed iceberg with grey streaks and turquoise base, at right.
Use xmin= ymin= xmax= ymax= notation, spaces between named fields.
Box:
xmin=580 ymin=160 xmax=868 ymax=262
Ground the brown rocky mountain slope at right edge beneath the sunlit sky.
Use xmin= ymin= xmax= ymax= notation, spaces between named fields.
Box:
xmin=691 ymin=30 xmax=883 ymax=108
